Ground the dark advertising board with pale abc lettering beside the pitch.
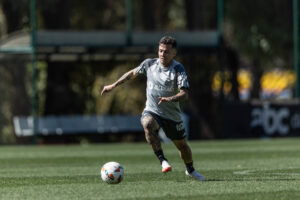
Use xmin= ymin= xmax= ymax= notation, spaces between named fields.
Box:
xmin=223 ymin=101 xmax=300 ymax=138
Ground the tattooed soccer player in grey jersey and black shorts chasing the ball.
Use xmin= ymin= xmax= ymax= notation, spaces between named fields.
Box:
xmin=101 ymin=36 xmax=205 ymax=181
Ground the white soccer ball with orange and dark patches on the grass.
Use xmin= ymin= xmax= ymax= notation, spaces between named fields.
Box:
xmin=101 ymin=162 xmax=124 ymax=184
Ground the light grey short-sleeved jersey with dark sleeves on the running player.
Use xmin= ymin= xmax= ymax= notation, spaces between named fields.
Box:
xmin=136 ymin=58 xmax=189 ymax=122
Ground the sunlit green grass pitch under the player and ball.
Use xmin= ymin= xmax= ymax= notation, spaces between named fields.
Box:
xmin=0 ymin=138 xmax=300 ymax=200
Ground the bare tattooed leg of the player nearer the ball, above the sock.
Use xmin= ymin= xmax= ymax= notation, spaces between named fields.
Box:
xmin=142 ymin=115 xmax=161 ymax=151
